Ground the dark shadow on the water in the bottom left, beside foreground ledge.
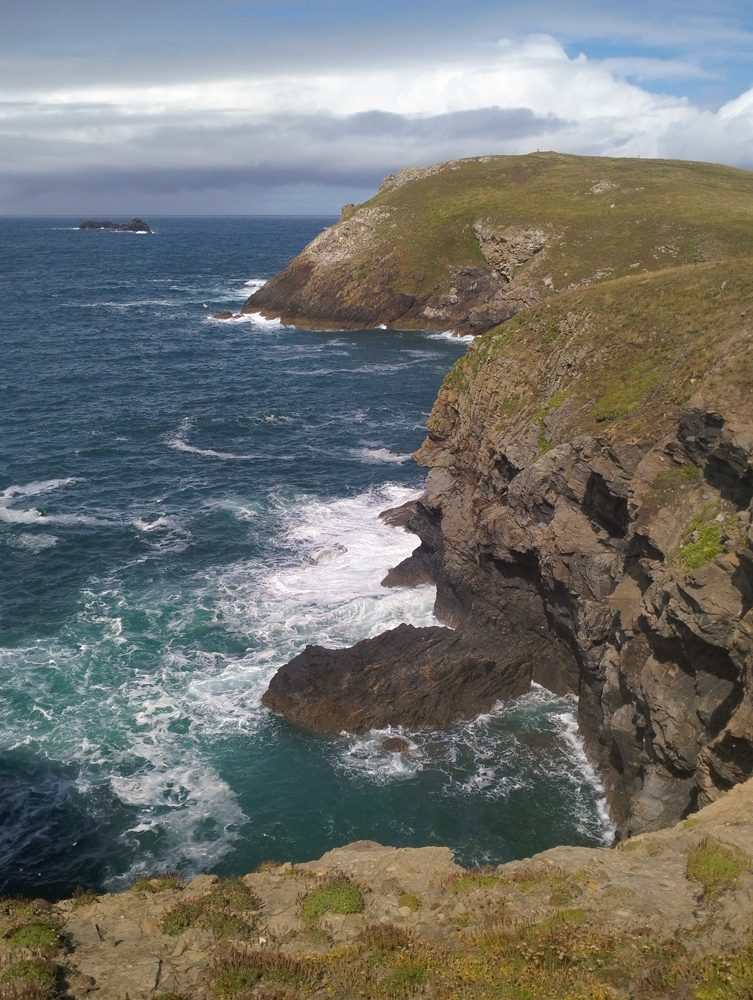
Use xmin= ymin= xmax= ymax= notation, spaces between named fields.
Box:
xmin=0 ymin=749 xmax=135 ymax=897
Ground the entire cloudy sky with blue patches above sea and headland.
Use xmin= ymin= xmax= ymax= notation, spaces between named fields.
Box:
xmin=0 ymin=0 xmax=753 ymax=215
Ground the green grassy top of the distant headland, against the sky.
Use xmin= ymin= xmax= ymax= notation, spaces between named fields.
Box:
xmin=368 ymin=153 xmax=753 ymax=294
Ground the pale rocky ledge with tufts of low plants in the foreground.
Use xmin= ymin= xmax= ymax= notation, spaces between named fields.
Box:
xmin=5 ymin=781 xmax=753 ymax=1000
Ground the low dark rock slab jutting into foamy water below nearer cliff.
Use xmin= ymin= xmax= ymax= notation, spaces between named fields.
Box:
xmin=262 ymin=625 xmax=531 ymax=733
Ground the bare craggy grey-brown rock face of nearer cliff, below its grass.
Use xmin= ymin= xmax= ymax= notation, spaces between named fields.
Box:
xmin=408 ymin=345 xmax=753 ymax=836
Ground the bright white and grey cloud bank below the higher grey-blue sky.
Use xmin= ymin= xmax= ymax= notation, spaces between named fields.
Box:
xmin=0 ymin=35 xmax=753 ymax=211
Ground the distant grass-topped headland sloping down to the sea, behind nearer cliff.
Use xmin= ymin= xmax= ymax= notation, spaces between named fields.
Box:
xmin=243 ymin=153 xmax=753 ymax=334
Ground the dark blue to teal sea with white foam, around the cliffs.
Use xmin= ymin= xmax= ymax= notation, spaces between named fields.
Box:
xmin=0 ymin=217 xmax=610 ymax=896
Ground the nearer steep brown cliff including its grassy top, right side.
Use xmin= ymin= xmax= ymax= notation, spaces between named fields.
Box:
xmin=406 ymin=262 xmax=753 ymax=836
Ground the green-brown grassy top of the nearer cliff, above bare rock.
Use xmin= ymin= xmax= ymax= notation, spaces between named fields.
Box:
xmin=428 ymin=259 xmax=753 ymax=446
